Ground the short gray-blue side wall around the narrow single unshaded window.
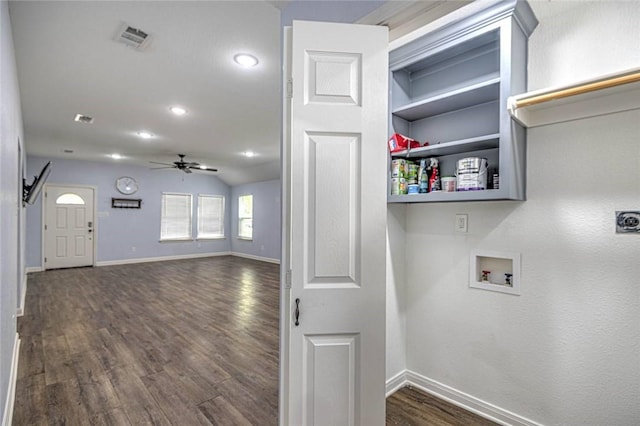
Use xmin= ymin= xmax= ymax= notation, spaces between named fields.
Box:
xmin=229 ymin=180 xmax=281 ymax=261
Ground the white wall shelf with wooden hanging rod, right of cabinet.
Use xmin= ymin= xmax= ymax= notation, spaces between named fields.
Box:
xmin=507 ymin=68 xmax=640 ymax=127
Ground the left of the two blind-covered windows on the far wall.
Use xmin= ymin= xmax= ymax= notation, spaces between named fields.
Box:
xmin=160 ymin=192 xmax=191 ymax=241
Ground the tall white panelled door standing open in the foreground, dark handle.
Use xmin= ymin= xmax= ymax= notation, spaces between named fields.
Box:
xmin=281 ymin=21 xmax=388 ymax=426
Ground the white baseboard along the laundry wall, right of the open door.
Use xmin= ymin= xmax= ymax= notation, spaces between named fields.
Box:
xmin=386 ymin=370 xmax=542 ymax=426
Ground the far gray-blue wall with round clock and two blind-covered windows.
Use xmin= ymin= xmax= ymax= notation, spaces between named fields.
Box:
xmin=26 ymin=156 xmax=231 ymax=267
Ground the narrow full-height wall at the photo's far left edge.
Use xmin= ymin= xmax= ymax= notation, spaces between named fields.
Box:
xmin=0 ymin=1 xmax=23 ymax=421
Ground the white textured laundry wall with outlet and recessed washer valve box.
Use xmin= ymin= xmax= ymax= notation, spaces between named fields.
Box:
xmin=398 ymin=2 xmax=640 ymax=426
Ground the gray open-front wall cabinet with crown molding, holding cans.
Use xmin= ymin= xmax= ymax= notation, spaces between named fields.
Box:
xmin=387 ymin=0 xmax=538 ymax=203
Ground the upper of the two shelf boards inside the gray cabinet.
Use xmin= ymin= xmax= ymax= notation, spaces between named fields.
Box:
xmin=392 ymin=77 xmax=500 ymax=121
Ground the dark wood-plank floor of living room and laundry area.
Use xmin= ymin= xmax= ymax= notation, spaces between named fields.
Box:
xmin=13 ymin=256 xmax=492 ymax=426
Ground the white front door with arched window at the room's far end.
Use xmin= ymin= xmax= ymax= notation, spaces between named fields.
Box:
xmin=44 ymin=185 xmax=95 ymax=269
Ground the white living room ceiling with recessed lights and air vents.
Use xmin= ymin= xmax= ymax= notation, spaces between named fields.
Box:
xmin=9 ymin=1 xmax=282 ymax=185
